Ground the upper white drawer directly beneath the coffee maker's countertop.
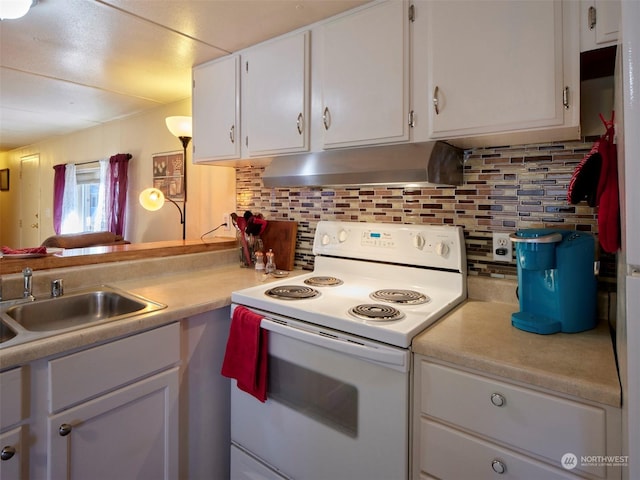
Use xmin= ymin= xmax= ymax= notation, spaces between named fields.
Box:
xmin=421 ymin=362 xmax=607 ymax=477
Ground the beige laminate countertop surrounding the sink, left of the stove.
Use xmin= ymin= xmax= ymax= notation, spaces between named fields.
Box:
xmin=0 ymin=263 xmax=304 ymax=369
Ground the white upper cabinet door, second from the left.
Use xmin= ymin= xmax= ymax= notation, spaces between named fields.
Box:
xmin=242 ymin=32 xmax=309 ymax=157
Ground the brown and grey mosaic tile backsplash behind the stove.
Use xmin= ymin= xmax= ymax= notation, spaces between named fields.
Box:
xmin=236 ymin=138 xmax=615 ymax=284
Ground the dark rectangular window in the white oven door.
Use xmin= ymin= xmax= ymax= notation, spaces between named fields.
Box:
xmin=268 ymin=356 xmax=358 ymax=438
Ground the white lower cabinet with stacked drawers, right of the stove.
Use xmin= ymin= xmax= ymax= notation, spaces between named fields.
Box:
xmin=413 ymin=355 xmax=621 ymax=480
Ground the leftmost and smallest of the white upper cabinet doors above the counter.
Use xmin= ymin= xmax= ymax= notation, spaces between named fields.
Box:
xmin=192 ymin=55 xmax=240 ymax=163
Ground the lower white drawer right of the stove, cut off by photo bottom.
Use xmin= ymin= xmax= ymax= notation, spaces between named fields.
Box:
xmin=420 ymin=418 xmax=576 ymax=480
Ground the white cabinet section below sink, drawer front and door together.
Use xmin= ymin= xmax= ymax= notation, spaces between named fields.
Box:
xmin=24 ymin=322 xmax=181 ymax=480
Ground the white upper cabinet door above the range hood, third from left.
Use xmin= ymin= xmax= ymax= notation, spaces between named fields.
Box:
xmin=320 ymin=1 xmax=409 ymax=148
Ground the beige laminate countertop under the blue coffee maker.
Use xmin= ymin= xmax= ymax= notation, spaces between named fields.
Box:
xmin=412 ymin=300 xmax=621 ymax=407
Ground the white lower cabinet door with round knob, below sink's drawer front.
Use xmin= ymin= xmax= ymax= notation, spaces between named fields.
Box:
xmin=47 ymin=367 xmax=179 ymax=480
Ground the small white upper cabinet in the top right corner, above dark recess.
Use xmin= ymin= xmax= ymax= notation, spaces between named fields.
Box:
xmin=580 ymin=0 xmax=620 ymax=52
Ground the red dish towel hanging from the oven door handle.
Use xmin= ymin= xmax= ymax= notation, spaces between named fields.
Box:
xmin=220 ymin=307 xmax=268 ymax=402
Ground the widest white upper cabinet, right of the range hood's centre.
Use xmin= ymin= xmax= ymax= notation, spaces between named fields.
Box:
xmin=419 ymin=0 xmax=580 ymax=146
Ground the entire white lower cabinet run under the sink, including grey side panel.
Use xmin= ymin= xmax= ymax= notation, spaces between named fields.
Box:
xmin=7 ymin=307 xmax=231 ymax=480
